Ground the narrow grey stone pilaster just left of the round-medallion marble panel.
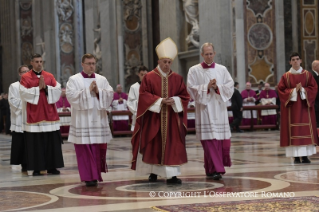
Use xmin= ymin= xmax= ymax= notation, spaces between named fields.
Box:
xmin=235 ymin=0 xmax=246 ymax=90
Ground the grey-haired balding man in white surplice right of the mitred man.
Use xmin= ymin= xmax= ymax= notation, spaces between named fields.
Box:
xmin=187 ymin=43 xmax=234 ymax=180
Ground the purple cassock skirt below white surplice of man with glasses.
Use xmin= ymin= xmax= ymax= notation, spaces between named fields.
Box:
xmin=74 ymin=144 xmax=107 ymax=182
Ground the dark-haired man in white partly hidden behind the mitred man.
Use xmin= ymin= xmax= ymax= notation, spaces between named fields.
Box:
xmin=127 ymin=66 xmax=148 ymax=131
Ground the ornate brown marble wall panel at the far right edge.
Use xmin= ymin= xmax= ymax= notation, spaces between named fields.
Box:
xmin=300 ymin=0 xmax=319 ymax=70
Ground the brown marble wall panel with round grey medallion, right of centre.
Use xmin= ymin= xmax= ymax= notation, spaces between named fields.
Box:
xmin=244 ymin=0 xmax=277 ymax=86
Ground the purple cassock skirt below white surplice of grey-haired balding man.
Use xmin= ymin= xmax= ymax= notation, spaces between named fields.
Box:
xmin=201 ymin=139 xmax=231 ymax=174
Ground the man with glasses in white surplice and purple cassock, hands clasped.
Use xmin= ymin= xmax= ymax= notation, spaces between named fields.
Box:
xmin=66 ymin=54 xmax=113 ymax=186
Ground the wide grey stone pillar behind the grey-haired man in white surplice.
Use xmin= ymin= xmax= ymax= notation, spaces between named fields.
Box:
xmin=199 ymin=0 xmax=232 ymax=73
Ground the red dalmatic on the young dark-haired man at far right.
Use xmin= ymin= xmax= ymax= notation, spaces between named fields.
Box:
xmin=278 ymin=70 xmax=318 ymax=147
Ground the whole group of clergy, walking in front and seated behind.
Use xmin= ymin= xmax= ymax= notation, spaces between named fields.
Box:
xmin=8 ymin=38 xmax=319 ymax=186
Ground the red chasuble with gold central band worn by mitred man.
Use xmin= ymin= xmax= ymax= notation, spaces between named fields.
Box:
xmin=131 ymin=69 xmax=189 ymax=170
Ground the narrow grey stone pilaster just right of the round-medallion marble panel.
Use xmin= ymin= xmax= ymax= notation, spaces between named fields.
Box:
xmin=275 ymin=1 xmax=287 ymax=83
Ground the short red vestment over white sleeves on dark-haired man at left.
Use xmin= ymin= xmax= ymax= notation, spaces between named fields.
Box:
xmin=20 ymin=71 xmax=60 ymax=124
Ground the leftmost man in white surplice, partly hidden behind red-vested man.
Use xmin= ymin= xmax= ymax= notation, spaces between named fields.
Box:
xmin=8 ymin=65 xmax=29 ymax=172
